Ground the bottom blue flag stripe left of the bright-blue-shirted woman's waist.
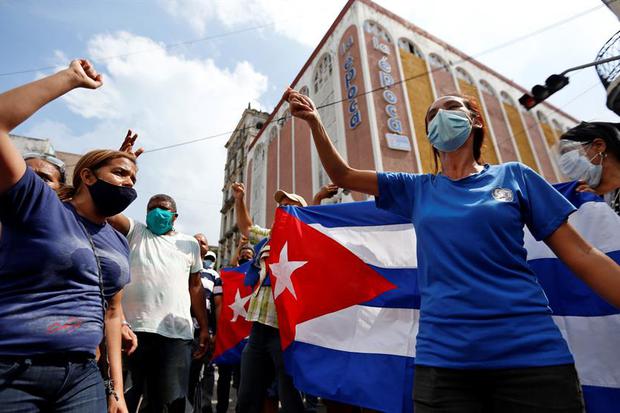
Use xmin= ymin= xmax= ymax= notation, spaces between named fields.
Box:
xmin=284 ymin=342 xmax=414 ymax=413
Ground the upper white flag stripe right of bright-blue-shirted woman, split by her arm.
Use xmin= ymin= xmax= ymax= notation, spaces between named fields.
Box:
xmin=524 ymin=201 xmax=620 ymax=260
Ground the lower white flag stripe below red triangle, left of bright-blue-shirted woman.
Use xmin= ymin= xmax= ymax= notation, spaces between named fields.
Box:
xmin=295 ymin=305 xmax=420 ymax=357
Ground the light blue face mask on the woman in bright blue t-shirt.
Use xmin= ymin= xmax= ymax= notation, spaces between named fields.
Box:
xmin=428 ymin=109 xmax=472 ymax=152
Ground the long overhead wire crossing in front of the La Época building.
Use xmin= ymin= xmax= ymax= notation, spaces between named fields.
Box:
xmin=144 ymin=0 xmax=620 ymax=153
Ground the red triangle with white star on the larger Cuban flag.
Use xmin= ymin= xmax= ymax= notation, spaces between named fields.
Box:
xmin=268 ymin=208 xmax=396 ymax=349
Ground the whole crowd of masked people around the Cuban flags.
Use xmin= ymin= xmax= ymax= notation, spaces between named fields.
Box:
xmin=0 ymin=60 xmax=620 ymax=413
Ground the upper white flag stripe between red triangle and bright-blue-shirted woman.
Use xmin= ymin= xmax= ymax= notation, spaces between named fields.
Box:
xmin=310 ymin=224 xmax=418 ymax=268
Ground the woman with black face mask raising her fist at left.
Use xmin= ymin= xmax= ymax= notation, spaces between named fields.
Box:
xmin=0 ymin=60 xmax=137 ymax=412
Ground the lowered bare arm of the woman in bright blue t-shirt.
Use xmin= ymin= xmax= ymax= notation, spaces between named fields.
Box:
xmin=545 ymin=223 xmax=620 ymax=308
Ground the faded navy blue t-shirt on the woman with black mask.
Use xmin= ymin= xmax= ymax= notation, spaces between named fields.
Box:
xmin=0 ymin=168 xmax=129 ymax=356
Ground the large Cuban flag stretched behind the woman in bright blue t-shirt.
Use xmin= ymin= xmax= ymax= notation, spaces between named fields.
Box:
xmin=269 ymin=184 xmax=620 ymax=413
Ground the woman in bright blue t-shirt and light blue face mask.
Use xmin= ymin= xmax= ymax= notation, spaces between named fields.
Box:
xmin=284 ymin=89 xmax=620 ymax=413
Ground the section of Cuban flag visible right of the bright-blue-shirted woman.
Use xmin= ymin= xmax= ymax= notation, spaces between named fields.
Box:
xmin=525 ymin=182 xmax=620 ymax=413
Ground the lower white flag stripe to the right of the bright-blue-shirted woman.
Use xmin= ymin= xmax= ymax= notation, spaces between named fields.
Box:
xmin=553 ymin=314 xmax=620 ymax=388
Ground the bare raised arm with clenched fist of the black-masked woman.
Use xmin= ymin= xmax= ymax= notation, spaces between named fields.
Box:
xmin=0 ymin=60 xmax=102 ymax=194
